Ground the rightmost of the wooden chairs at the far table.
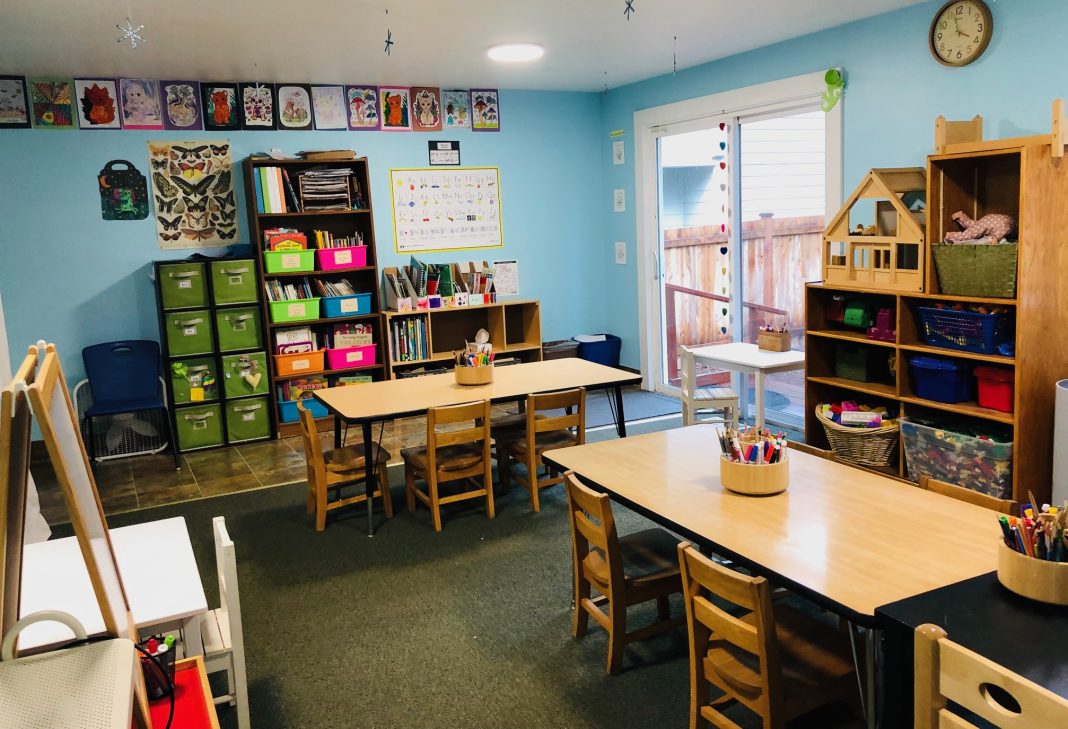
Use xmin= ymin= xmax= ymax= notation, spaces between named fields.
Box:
xmin=493 ymin=387 xmax=586 ymax=511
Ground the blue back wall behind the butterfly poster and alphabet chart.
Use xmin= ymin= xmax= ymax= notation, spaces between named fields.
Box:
xmin=0 ymin=89 xmax=603 ymax=382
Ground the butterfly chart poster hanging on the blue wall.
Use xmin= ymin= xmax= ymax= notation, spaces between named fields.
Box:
xmin=148 ymin=140 xmax=237 ymax=250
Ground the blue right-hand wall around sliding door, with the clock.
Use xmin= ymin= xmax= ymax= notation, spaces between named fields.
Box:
xmin=597 ymin=0 xmax=1068 ymax=367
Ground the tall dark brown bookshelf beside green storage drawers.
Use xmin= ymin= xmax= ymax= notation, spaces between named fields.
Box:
xmin=244 ymin=156 xmax=388 ymax=437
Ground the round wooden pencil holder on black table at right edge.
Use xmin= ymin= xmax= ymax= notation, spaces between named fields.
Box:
xmin=998 ymin=502 xmax=1068 ymax=605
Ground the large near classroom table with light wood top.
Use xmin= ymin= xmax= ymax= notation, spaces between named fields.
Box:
xmin=544 ymin=425 xmax=998 ymax=726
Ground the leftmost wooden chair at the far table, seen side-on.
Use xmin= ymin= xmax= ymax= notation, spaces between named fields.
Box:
xmin=297 ymin=400 xmax=393 ymax=532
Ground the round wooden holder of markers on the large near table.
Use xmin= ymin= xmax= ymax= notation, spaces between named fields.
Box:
xmin=717 ymin=429 xmax=790 ymax=496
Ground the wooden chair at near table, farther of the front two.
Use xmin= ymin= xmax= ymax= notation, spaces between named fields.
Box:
xmin=564 ymin=473 xmax=684 ymax=673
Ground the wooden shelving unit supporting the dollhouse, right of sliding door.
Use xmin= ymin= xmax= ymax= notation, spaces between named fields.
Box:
xmin=805 ymin=143 xmax=1068 ymax=502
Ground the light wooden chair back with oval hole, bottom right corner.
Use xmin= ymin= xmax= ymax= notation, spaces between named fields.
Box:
xmin=912 ymin=623 xmax=1068 ymax=729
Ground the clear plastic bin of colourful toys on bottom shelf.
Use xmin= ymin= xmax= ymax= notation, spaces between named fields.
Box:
xmin=900 ymin=419 xmax=1012 ymax=498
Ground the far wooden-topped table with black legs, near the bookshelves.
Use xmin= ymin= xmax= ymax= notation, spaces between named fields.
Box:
xmin=315 ymin=358 xmax=642 ymax=536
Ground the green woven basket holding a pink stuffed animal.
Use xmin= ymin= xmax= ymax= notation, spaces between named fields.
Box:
xmin=931 ymin=243 xmax=1019 ymax=299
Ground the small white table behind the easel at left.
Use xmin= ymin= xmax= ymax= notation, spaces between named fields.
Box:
xmin=18 ymin=517 xmax=207 ymax=656
